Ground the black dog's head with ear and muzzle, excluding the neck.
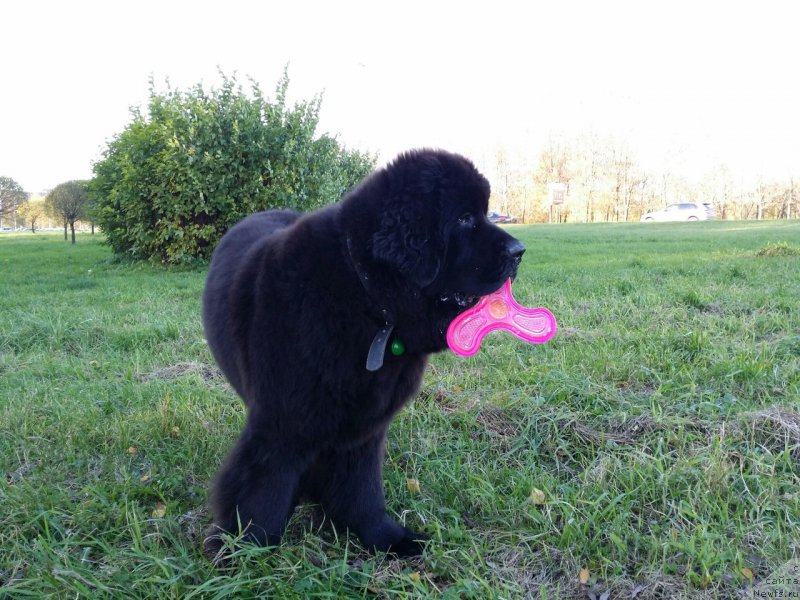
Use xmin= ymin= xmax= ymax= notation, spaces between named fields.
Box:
xmin=372 ymin=150 xmax=525 ymax=307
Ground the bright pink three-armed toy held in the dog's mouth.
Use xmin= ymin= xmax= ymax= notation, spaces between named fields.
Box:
xmin=447 ymin=279 xmax=556 ymax=356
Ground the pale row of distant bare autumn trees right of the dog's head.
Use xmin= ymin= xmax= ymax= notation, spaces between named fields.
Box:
xmin=492 ymin=134 xmax=800 ymax=223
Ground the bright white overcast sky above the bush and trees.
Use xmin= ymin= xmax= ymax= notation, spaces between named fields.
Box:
xmin=0 ymin=0 xmax=800 ymax=193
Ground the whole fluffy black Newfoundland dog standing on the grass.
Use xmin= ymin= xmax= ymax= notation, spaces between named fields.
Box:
xmin=203 ymin=150 xmax=525 ymax=556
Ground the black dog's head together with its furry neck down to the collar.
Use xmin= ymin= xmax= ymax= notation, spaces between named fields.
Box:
xmin=339 ymin=150 xmax=525 ymax=356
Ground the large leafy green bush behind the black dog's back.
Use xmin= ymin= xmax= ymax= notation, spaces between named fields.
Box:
xmin=91 ymin=74 xmax=375 ymax=263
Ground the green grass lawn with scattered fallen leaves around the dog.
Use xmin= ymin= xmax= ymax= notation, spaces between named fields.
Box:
xmin=0 ymin=221 xmax=800 ymax=599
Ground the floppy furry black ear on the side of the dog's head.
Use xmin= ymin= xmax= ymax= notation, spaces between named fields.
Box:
xmin=372 ymin=153 xmax=446 ymax=288
